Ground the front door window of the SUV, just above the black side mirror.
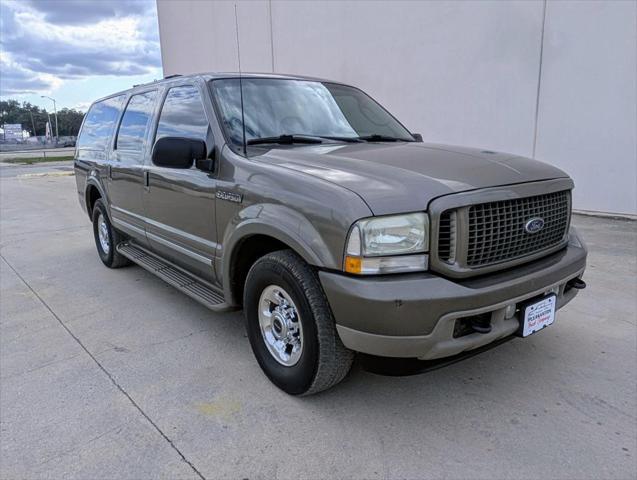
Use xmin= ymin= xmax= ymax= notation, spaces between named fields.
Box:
xmin=155 ymin=85 xmax=208 ymax=140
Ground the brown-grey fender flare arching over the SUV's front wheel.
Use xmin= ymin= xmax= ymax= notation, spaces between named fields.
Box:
xmin=217 ymin=204 xmax=343 ymax=299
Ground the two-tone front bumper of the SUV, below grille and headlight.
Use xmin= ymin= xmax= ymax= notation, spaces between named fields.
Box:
xmin=319 ymin=228 xmax=587 ymax=359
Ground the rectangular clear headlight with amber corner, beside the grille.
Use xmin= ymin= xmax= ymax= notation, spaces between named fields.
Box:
xmin=344 ymin=212 xmax=429 ymax=274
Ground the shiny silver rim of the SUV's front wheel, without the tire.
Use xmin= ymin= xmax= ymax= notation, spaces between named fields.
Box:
xmin=259 ymin=285 xmax=303 ymax=367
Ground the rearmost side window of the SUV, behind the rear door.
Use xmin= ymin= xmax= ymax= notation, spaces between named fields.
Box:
xmin=77 ymin=95 xmax=124 ymax=150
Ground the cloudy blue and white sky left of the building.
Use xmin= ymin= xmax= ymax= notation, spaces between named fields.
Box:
xmin=0 ymin=0 xmax=162 ymax=110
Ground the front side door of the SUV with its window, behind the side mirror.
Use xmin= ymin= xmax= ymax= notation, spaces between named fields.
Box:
xmin=143 ymin=82 xmax=217 ymax=282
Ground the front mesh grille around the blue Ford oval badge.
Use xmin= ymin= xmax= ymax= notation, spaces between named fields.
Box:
xmin=437 ymin=190 xmax=571 ymax=273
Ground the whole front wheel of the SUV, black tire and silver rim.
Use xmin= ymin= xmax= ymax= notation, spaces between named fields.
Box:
xmin=243 ymin=250 xmax=354 ymax=395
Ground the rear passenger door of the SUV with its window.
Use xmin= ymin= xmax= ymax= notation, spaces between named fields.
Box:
xmin=109 ymin=90 xmax=157 ymax=245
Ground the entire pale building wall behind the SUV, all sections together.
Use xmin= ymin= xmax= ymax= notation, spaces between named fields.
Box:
xmin=158 ymin=0 xmax=637 ymax=214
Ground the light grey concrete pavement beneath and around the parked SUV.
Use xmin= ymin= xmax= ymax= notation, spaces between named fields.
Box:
xmin=0 ymin=167 xmax=637 ymax=479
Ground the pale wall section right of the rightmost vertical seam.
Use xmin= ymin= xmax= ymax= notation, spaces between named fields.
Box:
xmin=536 ymin=1 xmax=637 ymax=214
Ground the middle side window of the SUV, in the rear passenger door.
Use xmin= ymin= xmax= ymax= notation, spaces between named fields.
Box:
xmin=115 ymin=91 xmax=157 ymax=152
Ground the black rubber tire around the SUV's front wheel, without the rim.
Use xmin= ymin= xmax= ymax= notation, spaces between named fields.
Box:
xmin=243 ymin=250 xmax=354 ymax=395
